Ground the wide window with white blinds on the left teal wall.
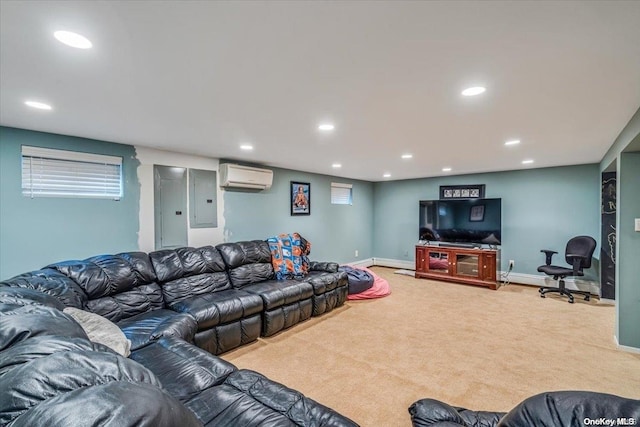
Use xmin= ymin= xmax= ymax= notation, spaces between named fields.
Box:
xmin=22 ymin=145 xmax=122 ymax=200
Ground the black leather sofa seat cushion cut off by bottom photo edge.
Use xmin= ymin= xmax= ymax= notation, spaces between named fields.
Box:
xmin=185 ymin=369 xmax=357 ymax=427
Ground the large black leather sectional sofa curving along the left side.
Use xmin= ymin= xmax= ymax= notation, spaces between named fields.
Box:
xmin=0 ymin=241 xmax=357 ymax=427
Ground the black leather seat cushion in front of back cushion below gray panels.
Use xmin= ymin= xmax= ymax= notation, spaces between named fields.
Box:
xmin=170 ymin=289 xmax=263 ymax=331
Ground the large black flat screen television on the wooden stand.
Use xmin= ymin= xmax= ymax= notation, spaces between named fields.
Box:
xmin=419 ymin=199 xmax=502 ymax=246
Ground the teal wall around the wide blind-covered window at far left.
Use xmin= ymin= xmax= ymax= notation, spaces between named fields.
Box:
xmin=0 ymin=127 xmax=140 ymax=280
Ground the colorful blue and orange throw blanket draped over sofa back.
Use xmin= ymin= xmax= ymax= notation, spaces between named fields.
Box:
xmin=267 ymin=233 xmax=311 ymax=280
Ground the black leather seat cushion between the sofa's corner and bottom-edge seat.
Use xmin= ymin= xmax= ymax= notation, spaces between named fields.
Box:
xmin=131 ymin=337 xmax=236 ymax=401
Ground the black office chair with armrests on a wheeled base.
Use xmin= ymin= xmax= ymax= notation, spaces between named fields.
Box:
xmin=538 ymin=236 xmax=596 ymax=304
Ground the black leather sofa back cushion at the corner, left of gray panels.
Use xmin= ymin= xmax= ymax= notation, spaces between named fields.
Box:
xmin=47 ymin=252 xmax=165 ymax=322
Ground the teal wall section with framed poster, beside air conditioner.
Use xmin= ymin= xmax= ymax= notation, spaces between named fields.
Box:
xmin=223 ymin=168 xmax=373 ymax=263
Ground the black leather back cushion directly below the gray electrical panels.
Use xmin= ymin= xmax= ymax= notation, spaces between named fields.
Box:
xmin=149 ymin=246 xmax=231 ymax=305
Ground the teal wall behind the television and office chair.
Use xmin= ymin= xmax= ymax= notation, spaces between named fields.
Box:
xmin=373 ymin=164 xmax=600 ymax=280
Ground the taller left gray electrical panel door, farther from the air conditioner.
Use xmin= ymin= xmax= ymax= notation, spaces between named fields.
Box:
xmin=153 ymin=165 xmax=187 ymax=249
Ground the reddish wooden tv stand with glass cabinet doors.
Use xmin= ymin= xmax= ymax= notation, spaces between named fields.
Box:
xmin=416 ymin=245 xmax=500 ymax=290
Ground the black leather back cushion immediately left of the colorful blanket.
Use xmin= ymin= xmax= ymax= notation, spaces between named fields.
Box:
xmin=216 ymin=240 xmax=274 ymax=288
